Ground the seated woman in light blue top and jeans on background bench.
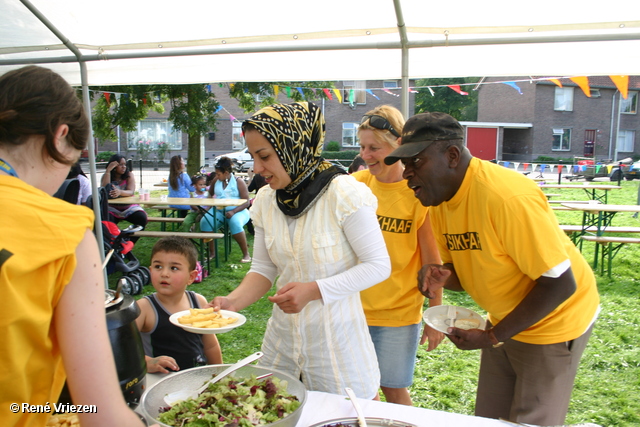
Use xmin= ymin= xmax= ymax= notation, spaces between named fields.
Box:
xmin=200 ymin=157 xmax=251 ymax=263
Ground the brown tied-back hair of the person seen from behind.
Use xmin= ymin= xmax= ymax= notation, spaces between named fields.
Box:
xmin=0 ymin=65 xmax=90 ymax=165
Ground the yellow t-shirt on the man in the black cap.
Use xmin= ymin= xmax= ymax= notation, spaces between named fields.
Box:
xmin=430 ymin=158 xmax=600 ymax=344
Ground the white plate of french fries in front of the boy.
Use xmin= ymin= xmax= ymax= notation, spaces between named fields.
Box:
xmin=169 ymin=307 xmax=247 ymax=334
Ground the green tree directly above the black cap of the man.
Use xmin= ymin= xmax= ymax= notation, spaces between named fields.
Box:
xmin=415 ymin=77 xmax=479 ymax=121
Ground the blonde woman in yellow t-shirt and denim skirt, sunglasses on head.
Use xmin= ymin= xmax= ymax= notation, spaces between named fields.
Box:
xmin=352 ymin=105 xmax=444 ymax=405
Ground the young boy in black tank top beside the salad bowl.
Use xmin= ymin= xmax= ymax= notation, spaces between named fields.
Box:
xmin=136 ymin=237 xmax=222 ymax=373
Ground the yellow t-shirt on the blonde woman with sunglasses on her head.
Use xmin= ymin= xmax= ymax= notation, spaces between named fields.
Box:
xmin=352 ymin=170 xmax=428 ymax=327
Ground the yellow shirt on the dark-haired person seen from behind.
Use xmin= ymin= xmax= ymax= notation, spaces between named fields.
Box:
xmin=0 ymin=175 xmax=94 ymax=427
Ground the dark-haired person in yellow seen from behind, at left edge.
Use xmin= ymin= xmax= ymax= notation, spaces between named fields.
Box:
xmin=0 ymin=66 xmax=143 ymax=427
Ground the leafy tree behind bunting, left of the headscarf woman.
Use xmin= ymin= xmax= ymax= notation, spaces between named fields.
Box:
xmin=91 ymin=82 xmax=340 ymax=175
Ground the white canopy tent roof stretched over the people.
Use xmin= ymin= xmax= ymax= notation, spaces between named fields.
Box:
xmin=0 ymin=0 xmax=640 ymax=270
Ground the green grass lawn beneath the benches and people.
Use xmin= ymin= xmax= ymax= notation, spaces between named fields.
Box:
xmin=120 ymin=181 xmax=640 ymax=427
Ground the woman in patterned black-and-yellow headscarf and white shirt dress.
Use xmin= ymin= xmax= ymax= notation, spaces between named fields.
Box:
xmin=211 ymin=102 xmax=390 ymax=399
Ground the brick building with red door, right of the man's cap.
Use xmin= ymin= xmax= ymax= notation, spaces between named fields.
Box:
xmin=464 ymin=76 xmax=640 ymax=161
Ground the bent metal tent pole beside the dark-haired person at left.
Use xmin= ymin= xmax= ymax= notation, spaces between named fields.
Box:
xmin=20 ymin=0 xmax=109 ymax=287
